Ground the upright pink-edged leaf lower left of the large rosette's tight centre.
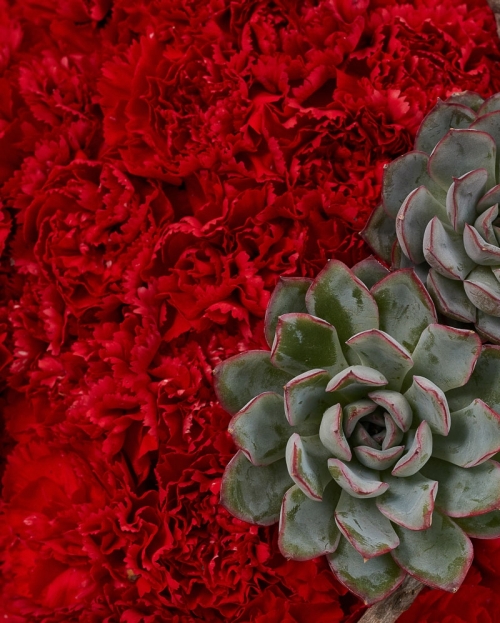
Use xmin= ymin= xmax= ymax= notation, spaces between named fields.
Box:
xmin=286 ymin=433 xmax=331 ymax=500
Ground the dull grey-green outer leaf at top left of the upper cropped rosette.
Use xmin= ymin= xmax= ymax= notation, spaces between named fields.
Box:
xmin=415 ymin=102 xmax=476 ymax=154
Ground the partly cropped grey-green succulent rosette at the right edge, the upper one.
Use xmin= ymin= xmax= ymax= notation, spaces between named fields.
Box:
xmin=362 ymin=92 xmax=500 ymax=344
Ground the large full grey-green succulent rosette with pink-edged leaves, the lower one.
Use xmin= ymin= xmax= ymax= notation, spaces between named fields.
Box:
xmin=215 ymin=258 xmax=500 ymax=603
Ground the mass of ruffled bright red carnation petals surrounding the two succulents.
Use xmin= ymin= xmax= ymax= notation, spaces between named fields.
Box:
xmin=0 ymin=0 xmax=500 ymax=623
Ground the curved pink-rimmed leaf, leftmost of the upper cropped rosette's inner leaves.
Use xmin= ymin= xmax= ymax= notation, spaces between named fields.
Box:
xmin=396 ymin=186 xmax=447 ymax=264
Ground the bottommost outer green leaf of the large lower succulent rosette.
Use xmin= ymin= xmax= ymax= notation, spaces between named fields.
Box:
xmin=327 ymin=539 xmax=406 ymax=605
